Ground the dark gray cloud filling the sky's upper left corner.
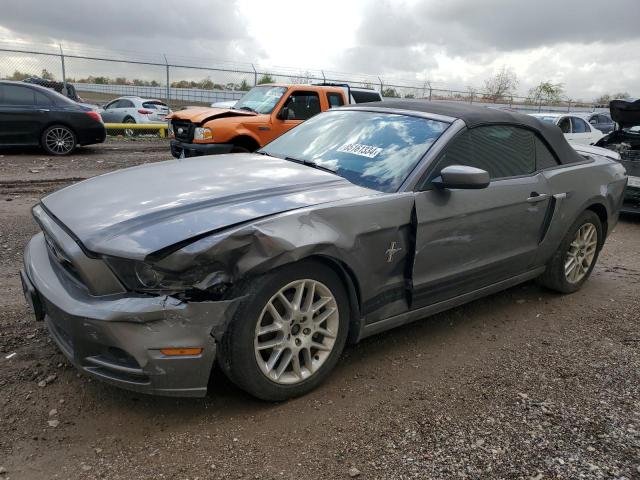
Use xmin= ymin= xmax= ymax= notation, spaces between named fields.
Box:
xmin=0 ymin=0 xmax=263 ymax=61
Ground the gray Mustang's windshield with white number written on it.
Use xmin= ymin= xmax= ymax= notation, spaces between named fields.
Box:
xmin=262 ymin=110 xmax=449 ymax=192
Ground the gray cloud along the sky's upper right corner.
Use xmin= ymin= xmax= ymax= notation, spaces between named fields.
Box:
xmin=350 ymin=0 xmax=640 ymax=55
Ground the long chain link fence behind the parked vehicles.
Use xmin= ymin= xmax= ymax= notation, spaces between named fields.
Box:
xmin=0 ymin=43 xmax=596 ymax=112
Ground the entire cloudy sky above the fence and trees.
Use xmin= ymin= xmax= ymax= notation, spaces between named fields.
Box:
xmin=0 ymin=0 xmax=640 ymax=99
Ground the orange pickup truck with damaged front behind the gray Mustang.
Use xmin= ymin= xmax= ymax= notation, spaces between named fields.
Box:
xmin=167 ymin=84 xmax=381 ymax=158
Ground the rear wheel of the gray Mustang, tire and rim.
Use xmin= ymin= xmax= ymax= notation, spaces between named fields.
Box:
xmin=538 ymin=210 xmax=604 ymax=293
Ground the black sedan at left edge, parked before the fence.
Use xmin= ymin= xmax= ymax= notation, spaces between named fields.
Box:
xmin=0 ymin=81 xmax=106 ymax=155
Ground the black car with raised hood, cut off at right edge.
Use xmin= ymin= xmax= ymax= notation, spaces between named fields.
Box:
xmin=596 ymin=100 xmax=640 ymax=213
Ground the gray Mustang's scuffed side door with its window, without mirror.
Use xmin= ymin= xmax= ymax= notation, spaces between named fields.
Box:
xmin=412 ymin=126 xmax=549 ymax=308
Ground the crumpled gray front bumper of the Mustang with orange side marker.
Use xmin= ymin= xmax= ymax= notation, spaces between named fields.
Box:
xmin=21 ymin=233 xmax=238 ymax=397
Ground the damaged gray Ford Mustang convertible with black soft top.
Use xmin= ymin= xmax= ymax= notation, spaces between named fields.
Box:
xmin=21 ymin=101 xmax=627 ymax=400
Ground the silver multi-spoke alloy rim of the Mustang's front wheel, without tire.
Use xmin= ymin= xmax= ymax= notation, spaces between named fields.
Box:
xmin=254 ymin=279 xmax=339 ymax=385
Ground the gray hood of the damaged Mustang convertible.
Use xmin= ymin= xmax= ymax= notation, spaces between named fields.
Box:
xmin=42 ymin=153 xmax=379 ymax=260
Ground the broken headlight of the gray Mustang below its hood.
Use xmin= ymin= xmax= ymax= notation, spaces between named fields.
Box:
xmin=104 ymin=257 xmax=226 ymax=293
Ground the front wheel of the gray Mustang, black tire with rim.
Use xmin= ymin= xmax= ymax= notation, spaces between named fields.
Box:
xmin=218 ymin=260 xmax=349 ymax=401
